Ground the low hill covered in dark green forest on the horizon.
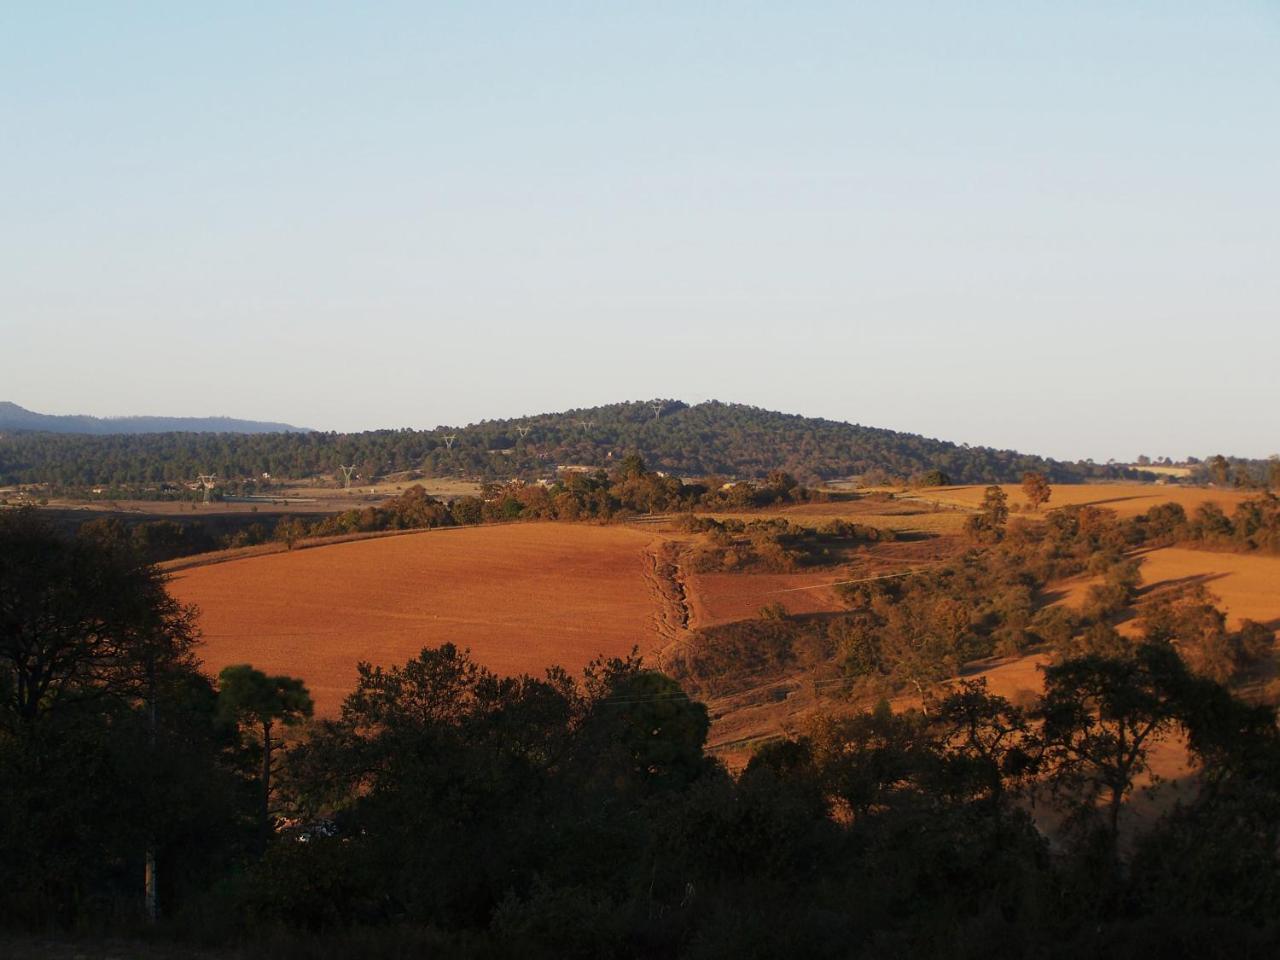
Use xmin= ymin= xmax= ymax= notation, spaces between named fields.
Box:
xmin=0 ymin=401 xmax=1141 ymax=485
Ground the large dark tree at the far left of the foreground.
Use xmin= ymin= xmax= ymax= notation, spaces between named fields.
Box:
xmin=0 ymin=511 xmax=251 ymax=924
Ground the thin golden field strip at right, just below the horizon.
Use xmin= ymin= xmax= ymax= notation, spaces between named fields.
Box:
xmin=902 ymin=484 xmax=1257 ymax=517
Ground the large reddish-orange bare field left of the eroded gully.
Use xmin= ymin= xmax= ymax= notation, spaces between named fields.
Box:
xmin=170 ymin=524 xmax=662 ymax=716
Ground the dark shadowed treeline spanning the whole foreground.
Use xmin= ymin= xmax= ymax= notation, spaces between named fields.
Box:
xmin=0 ymin=512 xmax=1280 ymax=959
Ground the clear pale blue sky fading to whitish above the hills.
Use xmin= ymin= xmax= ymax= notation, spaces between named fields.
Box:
xmin=0 ymin=0 xmax=1280 ymax=460
